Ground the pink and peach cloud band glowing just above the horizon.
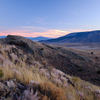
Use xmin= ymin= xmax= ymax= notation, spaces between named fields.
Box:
xmin=0 ymin=29 xmax=91 ymax=38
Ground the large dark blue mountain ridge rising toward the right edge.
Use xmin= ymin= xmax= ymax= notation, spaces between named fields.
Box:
xmin=40 ymin=30 xmax=100 ymax=43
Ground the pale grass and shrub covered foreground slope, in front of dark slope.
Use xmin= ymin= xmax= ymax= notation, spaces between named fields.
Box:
xmin=0 ymin=35 xmax=100 ymax=100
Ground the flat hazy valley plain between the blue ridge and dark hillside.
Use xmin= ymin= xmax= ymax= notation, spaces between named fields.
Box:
xmin=52 ymin=43 xmax=100 ymax=56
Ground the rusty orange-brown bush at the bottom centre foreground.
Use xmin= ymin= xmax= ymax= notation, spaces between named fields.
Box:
xmin=38 ymin=82 xmax=66 ymax=100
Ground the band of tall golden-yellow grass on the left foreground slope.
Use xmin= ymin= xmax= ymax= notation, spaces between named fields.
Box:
xmin=2 ymin=66 xmax=46 ymax=84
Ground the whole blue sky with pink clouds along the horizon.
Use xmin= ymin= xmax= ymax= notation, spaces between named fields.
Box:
xmin=0 ymin=0 xmax=100 ymax=38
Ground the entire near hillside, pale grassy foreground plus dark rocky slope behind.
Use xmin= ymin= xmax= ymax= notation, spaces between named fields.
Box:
xmin=0 ymin=35 xmax=100 ymax=100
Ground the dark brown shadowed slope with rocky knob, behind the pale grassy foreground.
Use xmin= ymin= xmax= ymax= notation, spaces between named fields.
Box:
xmin=1 ymin=35 xmax=100 ymax=85
